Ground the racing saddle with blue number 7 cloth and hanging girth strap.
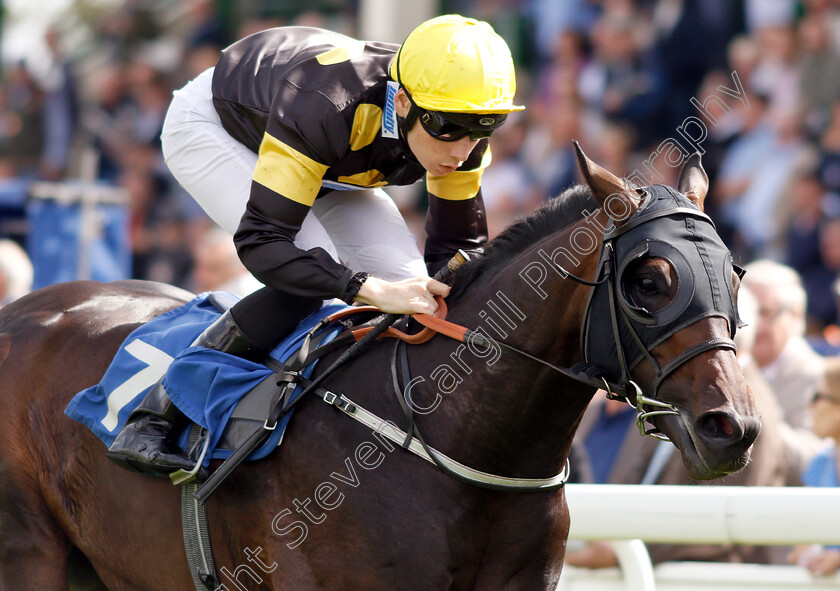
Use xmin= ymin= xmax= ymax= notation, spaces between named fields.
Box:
xmin=65 ymin=293 xmax=410 ymax=591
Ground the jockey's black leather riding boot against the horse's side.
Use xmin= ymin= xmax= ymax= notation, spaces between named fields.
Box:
xmin=106 ymin=311 xmax=256 ymax=474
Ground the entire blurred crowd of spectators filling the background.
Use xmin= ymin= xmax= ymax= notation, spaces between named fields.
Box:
xmin=0 ymin=0 xmax=840 ymax=572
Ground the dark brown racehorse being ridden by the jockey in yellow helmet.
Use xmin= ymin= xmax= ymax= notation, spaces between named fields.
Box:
xmin=0 ymin=148 xmax=760 ymax=591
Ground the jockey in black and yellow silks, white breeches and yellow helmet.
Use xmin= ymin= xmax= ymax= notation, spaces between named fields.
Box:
xmin=108 ymin=15 xmax=523 ymax=473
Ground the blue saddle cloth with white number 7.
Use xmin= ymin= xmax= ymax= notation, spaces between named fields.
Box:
xmin=64 ymin=293 xmax=347 ymax=464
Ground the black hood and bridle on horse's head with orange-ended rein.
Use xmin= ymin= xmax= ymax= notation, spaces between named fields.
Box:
xmin=392 ymin=185 xmax=742 ymax=468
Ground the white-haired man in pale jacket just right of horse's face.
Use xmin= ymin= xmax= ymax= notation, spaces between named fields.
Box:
xmin=742 ymin=260 xmax=824 ymax=485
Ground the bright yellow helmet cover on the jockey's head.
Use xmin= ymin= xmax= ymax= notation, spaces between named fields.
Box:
xmin=390 ymin=14 xmax=525 ymax=113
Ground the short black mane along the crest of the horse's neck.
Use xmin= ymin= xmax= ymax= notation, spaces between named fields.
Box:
xmin=449 ymin=185 xmax=598 ymax=299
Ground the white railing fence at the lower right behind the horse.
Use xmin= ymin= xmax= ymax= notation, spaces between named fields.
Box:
xmin=557 ymin=484 xmax=840 ymax=591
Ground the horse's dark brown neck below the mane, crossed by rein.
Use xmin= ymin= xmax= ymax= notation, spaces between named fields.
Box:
xmin=424 ymin=217 xmax=597 ymax=476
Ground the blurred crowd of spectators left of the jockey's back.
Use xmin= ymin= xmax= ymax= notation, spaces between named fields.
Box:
xmin=0 ymin=0 xmax=286 ymax=305
